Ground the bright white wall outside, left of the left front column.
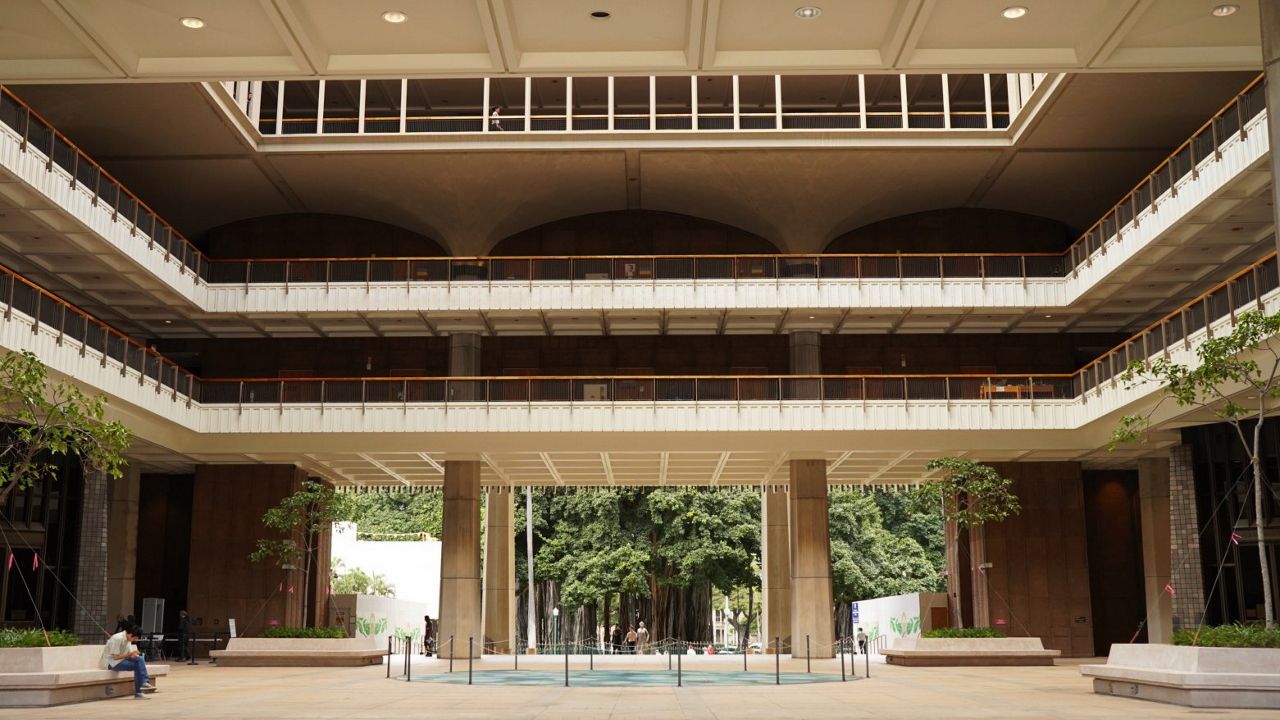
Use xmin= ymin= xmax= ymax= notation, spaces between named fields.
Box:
xmin=332 ymin=523 xmax=440 ymax=609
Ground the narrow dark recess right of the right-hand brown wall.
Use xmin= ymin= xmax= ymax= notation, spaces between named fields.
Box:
xmin=1084 ymin=470 xmax=1147 ymax=655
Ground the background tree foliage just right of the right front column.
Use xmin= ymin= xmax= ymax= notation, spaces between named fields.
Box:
xmin=829 ymin=491 xmax=940 ymax=603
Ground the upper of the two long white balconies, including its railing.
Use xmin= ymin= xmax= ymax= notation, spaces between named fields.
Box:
xmin=0 ymin=74 xmax=1270 ymax=333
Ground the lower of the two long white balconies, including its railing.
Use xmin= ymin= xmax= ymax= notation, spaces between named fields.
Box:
xmin=0 ymin=224 xmax=1280 ymax=479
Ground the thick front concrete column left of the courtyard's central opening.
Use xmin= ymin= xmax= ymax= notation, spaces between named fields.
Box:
xmin=436 ymin=460 xmax=484 ymax=657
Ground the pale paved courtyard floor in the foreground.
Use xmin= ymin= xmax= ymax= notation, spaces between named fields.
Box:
xmin=0 ymin=656 xmax=1280 ymax=720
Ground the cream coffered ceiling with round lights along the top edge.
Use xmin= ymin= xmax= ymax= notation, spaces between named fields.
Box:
xmin=0 ymin=0 xmax=1262 ymax=82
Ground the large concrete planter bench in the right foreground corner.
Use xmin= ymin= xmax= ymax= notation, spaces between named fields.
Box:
xmin=1080 ymin=644 xmax=1280 ymax=710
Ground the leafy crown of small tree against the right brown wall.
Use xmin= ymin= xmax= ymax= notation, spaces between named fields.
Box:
xmin=911 ymin=457 xmax=1023 ymax=528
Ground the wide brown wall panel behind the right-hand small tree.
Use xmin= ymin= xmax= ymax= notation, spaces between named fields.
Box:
xmin=974 ymin=462 xmax=1094 ymax=657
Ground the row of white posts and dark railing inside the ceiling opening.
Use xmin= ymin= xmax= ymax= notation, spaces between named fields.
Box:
xmin=220 ymin=73 xmax=1050 ymax=137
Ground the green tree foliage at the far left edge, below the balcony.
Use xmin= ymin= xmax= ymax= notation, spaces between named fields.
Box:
xmin=0 ymin=352 xmax=131 ymax=502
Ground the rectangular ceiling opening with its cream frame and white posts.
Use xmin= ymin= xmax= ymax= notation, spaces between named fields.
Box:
xmin=205 ymin=73 xmax=1059 ymax=152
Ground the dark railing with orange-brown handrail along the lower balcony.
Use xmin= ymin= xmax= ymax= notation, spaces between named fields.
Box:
xmin=0 ymin=254 xmax=1280 ymax=406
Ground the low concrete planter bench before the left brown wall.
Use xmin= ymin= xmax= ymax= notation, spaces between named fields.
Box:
xmin=209 ymin=638 xmax=387 ymax=667
